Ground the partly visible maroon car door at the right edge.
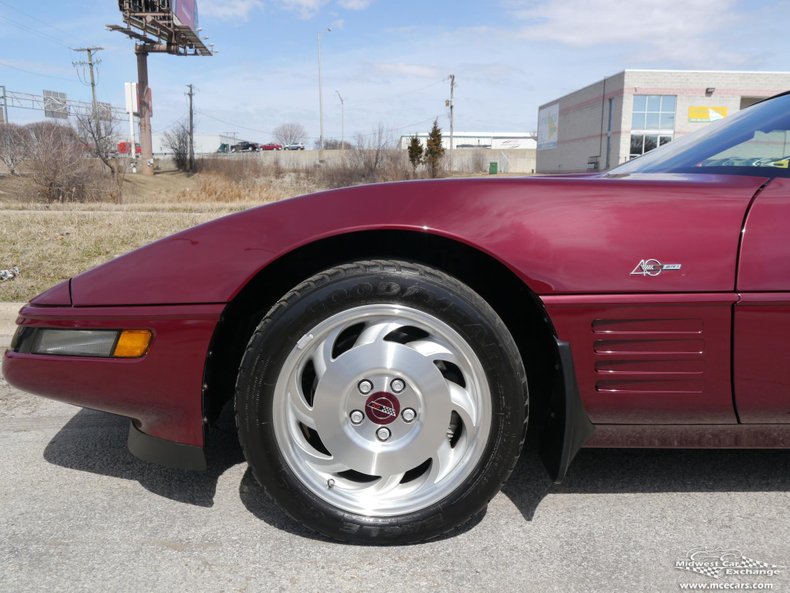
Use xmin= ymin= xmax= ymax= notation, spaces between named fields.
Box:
xmin=733 ymin=178 xmax=790 ymax=424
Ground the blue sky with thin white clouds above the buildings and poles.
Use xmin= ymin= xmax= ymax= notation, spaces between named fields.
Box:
xmin=0 ymin=0 xmax=790 ymax=142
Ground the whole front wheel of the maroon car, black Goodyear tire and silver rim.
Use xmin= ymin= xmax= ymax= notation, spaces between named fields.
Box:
xmin=235 ymin=261 xmax=528 ymax=544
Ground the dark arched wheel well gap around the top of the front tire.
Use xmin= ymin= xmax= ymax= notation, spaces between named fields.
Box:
xmin=203 ymin=231 xmax=558 ymax=424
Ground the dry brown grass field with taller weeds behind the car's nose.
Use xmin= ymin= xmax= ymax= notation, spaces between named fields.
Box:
xmin=0 ymin=151 xmax=442 ymax=301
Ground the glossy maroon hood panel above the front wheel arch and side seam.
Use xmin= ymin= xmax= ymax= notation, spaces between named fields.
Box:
xmin=65 ymin=175 xmax=766 ymax=306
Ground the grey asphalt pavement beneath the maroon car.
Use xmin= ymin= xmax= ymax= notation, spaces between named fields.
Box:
xmin=0 ymin=305 xmax=790 ymax=593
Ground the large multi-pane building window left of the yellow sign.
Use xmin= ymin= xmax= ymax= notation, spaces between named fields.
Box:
xmin=630 ymin=95 xmax=677 ymax=159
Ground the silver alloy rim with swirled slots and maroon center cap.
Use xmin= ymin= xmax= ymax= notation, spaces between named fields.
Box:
xmin=272 ymin=304 xmax=492 ymax=517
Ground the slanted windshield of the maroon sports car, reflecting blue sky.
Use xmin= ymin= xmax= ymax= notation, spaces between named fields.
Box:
xmin=607 ymin=94 xmax=790 ymax=177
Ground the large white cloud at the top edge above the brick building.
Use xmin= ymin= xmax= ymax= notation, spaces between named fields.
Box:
xmin=506 ymin=0 xmax=744 ymax=60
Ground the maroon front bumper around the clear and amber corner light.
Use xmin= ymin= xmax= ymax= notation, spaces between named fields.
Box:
xmin=3 ymin=304 xmax=225 ymax=468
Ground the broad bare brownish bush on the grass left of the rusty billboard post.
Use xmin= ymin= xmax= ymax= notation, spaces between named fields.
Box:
xmin=26 ymin=122 xmax=93 ymax=202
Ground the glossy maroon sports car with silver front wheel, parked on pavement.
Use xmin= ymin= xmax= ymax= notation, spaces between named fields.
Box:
xmin=3 ymin=94 xmax=790 ymax=543
